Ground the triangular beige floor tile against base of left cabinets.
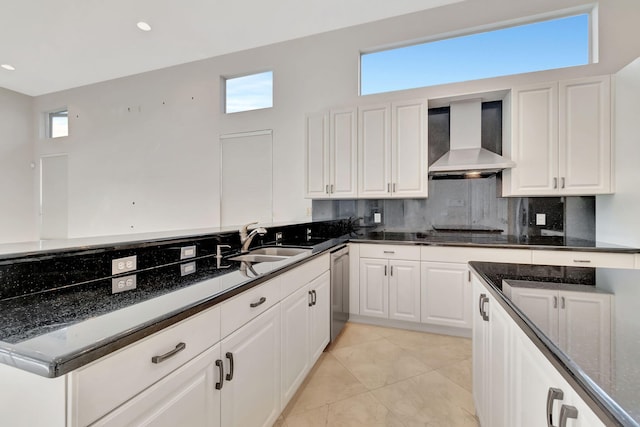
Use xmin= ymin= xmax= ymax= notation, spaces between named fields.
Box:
xmin=284 ymin=353 xmax=367 ymax=419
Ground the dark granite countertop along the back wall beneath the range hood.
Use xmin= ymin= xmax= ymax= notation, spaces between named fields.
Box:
xmin=351 ymin=230 xmax=640 ymax=253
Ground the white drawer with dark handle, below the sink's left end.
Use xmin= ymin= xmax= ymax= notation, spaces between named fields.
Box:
xmin=220 ymin=277 xmax=280 ymax=338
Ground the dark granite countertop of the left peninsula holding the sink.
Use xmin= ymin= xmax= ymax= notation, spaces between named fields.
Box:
xmin=0 ymin=238 xmax=346 ymax=377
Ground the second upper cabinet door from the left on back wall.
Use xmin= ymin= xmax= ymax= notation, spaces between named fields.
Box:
xmin=329 ymin=108 xmax=358 ymax=199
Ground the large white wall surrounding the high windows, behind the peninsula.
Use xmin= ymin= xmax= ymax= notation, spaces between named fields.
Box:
xmin=23 ymin=0 xmax=640 ymax=241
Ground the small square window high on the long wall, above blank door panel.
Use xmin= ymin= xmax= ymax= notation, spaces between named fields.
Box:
xmin=224 ymin=71 xmax=273 ymax=113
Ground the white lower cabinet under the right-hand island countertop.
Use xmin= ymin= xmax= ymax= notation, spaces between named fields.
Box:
xmin=472 ymin=277 xmax=604 ymax=427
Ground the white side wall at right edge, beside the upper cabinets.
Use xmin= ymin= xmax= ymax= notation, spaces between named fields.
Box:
xmin=596 ymin=58 xmax=640 ymax=247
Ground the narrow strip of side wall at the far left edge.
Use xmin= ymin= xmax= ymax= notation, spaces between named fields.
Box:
xmin=0 ymin=88 xmax=38 ymax=243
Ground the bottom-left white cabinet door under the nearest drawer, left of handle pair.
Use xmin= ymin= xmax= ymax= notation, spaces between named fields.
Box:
xmin=92 ymin=344 xmax=225 ymax=427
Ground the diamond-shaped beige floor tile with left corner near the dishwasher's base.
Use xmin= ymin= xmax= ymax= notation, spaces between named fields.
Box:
xmin=332 ymin=338 xmax=432 ymax=390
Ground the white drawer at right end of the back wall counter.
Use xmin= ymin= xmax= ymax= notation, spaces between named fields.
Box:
xmin=531 ymin=250 xmax=634 ymax=268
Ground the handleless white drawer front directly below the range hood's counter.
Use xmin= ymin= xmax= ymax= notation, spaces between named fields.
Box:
xmin=420 ymin=246 xmax=531 ymax=264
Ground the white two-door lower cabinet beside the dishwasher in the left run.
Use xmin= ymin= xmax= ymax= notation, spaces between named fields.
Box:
xmin=281 ymin=271 xmax=331 ymax=408
